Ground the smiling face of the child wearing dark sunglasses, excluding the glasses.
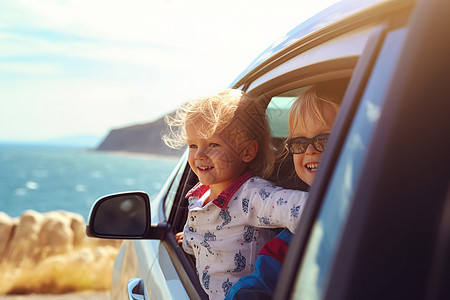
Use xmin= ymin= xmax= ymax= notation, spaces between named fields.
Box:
xmin=291 ymin=105 xmax=337 ymax=186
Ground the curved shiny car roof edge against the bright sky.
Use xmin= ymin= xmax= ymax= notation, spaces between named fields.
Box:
xmin=230 ymin=0 xmax=414 ymax=88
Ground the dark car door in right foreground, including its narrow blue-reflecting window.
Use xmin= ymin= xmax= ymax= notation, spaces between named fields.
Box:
xmin=275 ymin=0 xmax=450 ymax=299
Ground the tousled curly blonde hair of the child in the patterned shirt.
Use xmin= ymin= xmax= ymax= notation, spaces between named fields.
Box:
xmin=162 ymin=89 xmax=274 ymax=178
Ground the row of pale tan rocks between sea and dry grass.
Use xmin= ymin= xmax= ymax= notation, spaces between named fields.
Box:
xmin=0 ymin=210 xmax=121 ymax=265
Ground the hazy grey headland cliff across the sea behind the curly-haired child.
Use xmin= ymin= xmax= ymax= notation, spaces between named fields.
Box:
xmin=96 ymin=114 xmax=183 ymax=156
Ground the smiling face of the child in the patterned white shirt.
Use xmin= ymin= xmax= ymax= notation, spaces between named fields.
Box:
xmin=186 ymin=121 xmax=250 ymax=199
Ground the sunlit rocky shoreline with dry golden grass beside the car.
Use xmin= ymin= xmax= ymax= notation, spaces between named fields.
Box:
xmin=0 ymin=210 xmax=121 ymax=299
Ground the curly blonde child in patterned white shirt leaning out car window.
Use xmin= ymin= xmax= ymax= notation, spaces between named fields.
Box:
xmin=164 ymin=90 xmax=307 ymax=299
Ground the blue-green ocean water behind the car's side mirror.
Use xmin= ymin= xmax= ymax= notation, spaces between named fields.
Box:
xmin=0 ymin=144 xmax=177 ymax=220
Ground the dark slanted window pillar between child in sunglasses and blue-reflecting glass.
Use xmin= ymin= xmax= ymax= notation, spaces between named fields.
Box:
xmin=274 ymin=22 xmax=394 ymax=299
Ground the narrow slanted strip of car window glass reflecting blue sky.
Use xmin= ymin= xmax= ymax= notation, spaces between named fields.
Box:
xmin=294 ymin=29 xmax=406 ymax=300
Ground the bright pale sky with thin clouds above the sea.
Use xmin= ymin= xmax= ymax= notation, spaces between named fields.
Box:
xmin=0 ymin=0 xmax=337 ymax=141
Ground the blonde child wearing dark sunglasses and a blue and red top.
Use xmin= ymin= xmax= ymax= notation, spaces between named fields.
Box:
xmin=225 ymin=80 xmax=347 ymax=300
